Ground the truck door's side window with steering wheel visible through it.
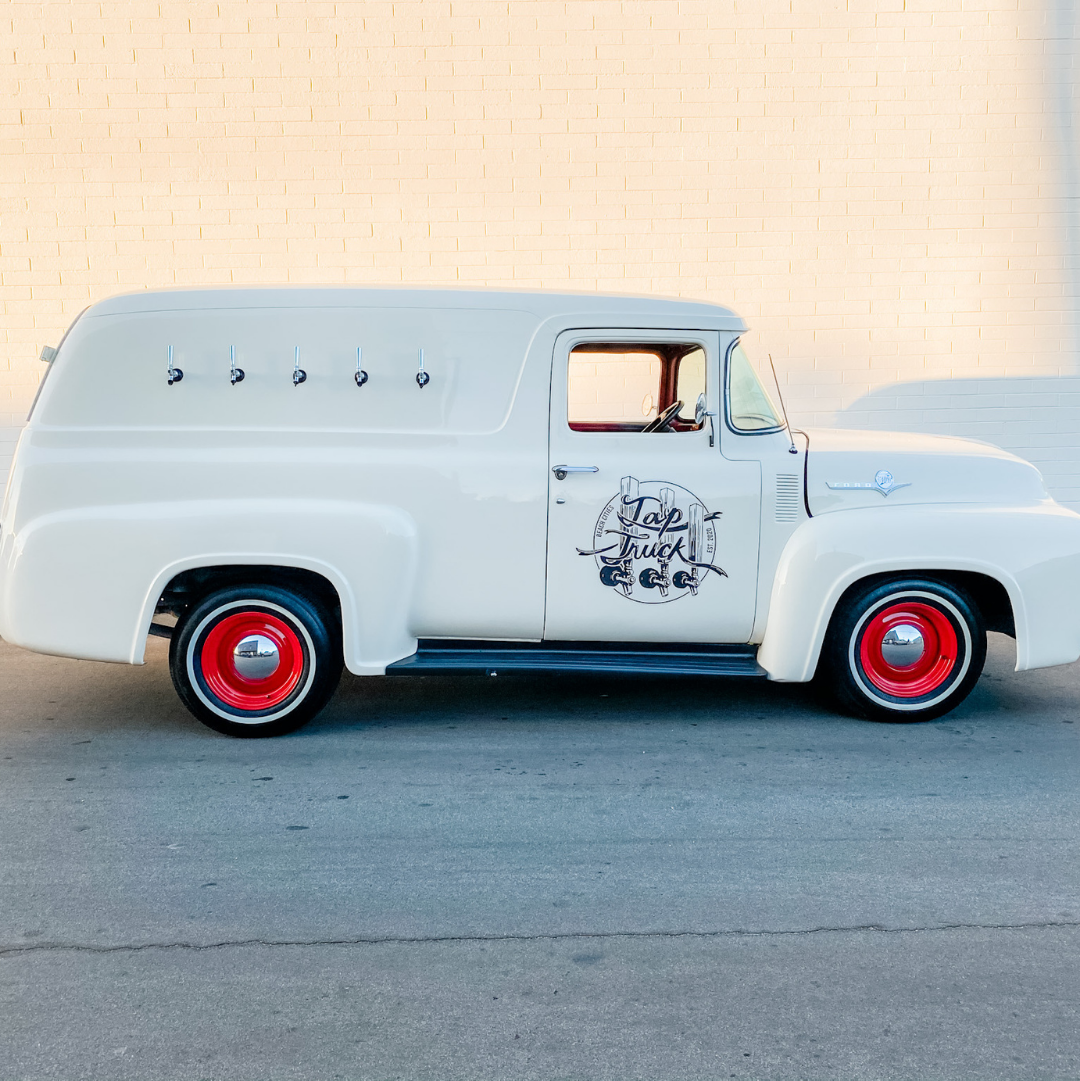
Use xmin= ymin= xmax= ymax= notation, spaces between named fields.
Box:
xmin=566 ymin=342 xmax=705 ymax=432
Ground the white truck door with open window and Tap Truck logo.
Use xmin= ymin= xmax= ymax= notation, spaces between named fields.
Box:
xmin=544 ymin=330 xmax=761 ymax=643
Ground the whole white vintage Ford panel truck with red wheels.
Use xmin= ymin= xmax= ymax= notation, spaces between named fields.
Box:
xmin=0 ymin=288 xmax=1080 ymax=736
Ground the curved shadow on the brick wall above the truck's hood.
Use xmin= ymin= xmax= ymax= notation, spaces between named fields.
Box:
xmin=835 ymin=376 xmax=1080 ymax=510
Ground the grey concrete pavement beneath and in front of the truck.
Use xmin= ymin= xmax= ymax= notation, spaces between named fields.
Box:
xmin=0 ymin=636 xmax=1080 ymax=1081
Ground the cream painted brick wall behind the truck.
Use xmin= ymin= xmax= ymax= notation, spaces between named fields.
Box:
xmin=0 ymin=0 xmax=1080 ymax=504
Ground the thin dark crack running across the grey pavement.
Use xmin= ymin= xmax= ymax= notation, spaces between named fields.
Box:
xmin=0 ymin=920 xmax=1080 ymax=957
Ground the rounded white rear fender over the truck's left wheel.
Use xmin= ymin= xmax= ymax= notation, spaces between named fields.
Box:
xmin=0 ymin=499 xmax=417 ymax=673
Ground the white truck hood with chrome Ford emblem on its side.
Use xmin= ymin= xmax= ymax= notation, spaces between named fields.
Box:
xmin=806 ymin=428 xmax=1049 ymax=515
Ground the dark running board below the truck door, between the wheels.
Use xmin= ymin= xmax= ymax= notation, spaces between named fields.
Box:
xmin=386 ymin=638 xmax=765 ymax=677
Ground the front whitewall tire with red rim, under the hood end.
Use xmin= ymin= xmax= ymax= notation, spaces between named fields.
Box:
xmin=815 ymin=577 xmax=986 ymax=722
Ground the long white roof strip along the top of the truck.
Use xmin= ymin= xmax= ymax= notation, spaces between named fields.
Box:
xmin=86 ymin=285 xmax=746 ymax=331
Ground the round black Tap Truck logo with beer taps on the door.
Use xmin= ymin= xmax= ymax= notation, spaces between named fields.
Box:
xmin=577 ymin=477 xmax=728 ymax=604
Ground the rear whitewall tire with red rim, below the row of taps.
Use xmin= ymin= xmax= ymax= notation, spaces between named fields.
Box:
xmin=169 ymin=586 xmax=342 ymax=738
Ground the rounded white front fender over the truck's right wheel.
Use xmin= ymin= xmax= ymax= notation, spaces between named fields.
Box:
xmin=758 ymin=502 xmax=1080 ymax=683
